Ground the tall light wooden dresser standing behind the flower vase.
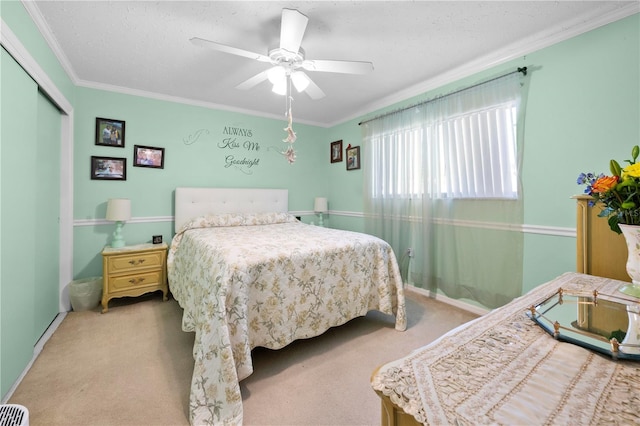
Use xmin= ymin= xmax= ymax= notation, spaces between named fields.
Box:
xmin=573 ymin=195 xmax=631 ymax=282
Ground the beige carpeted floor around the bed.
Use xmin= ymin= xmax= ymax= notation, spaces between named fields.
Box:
xmin=9 ymin=292 xmax=476 ymax=426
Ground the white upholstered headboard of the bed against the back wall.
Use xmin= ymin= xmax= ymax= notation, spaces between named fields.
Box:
xmin=174 ymin=188 xmax=289 ymax=231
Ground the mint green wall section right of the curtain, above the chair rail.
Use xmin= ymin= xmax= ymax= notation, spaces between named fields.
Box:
xmin=524 ymin=15 xmax=640 ymax=226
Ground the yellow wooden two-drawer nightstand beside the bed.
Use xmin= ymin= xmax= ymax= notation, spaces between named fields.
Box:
xmin=102 ymin=243 xmax=168 ymax=313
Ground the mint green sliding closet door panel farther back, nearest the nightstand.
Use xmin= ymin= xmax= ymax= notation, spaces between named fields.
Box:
xmin=33 ymin=92 xmax=61 ymax=342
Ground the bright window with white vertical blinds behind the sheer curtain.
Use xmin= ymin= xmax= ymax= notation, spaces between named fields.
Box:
xmin=370 ymin=100 xmax=518 ymax=199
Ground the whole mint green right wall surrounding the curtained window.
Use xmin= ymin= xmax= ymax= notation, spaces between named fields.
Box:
xmin=327 ymin=14 xmax=640 ymax=291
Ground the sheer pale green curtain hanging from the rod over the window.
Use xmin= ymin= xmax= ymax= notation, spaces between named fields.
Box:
xmin=362 ymin=73 xmax=523 ymax=308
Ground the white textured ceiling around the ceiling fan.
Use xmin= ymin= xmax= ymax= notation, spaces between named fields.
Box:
xmin=24 ymin=1 xmax=639 ymax=126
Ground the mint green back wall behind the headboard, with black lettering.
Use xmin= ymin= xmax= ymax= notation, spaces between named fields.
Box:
xmin=73 ymin=88 xmax=328 ymax=278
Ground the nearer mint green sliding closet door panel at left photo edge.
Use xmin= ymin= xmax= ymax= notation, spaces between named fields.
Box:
xmin=0 ymin=48 xmax=38 ymax=395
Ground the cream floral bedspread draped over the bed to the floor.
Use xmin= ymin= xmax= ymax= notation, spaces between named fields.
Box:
xmin=167 ymin=213 xmax=406 ymax=425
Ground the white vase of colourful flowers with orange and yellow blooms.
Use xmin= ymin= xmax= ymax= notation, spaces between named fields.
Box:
xmin=577 ymin=145 xmax=640 ymax=298
